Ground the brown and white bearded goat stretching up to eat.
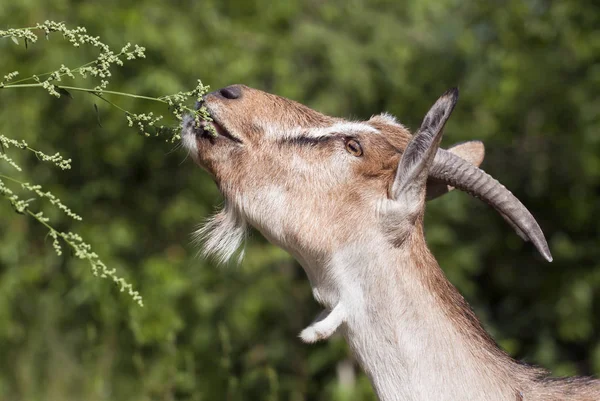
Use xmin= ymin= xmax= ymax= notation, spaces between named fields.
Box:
xmin=182 ymin=85 xmax=600 ymax=401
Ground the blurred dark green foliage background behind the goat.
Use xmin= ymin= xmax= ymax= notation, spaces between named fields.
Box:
xmin=0 ymin=0 xmax=600 ymax=401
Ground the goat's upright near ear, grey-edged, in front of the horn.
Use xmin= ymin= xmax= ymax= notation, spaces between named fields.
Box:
xmin=391 ymin=88 xmax=458 ymax=203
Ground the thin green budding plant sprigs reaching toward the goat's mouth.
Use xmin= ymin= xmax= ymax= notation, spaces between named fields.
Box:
xmin=0 ymin=21 xmax=216 ymax=306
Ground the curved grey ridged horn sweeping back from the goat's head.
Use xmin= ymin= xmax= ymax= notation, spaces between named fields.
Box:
xmin=429 ymin=149 xmax=552 ymax=262
